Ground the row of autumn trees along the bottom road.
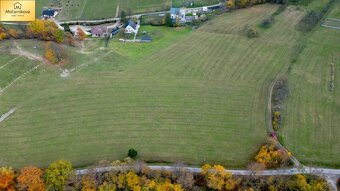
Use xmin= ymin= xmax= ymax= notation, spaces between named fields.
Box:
xmin=0 ymin=157 xmax=330 ymax=191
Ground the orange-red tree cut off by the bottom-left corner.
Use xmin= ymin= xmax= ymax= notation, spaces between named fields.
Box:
xmin=0 ymin=167 xmax=15 ymax=191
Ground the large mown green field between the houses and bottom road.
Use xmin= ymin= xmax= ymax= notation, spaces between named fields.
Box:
xmin=0 ymin=4 xmax=303 ymax=168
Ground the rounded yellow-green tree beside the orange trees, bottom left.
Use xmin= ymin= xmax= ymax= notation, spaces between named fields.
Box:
xmin=45 ymin=160 xmax=73 ymax=191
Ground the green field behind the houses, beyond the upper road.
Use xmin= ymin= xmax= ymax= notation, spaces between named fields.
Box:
xmin=36 ymin=0 xmax=219 ymax=20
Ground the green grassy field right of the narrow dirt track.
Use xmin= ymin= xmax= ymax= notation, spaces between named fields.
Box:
xmin=281 ymin=2 xmax=340 ymax=167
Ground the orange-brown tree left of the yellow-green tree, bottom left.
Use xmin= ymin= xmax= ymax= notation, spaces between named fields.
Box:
xmin=17 ymin=166 xmax=46 ymax=191
